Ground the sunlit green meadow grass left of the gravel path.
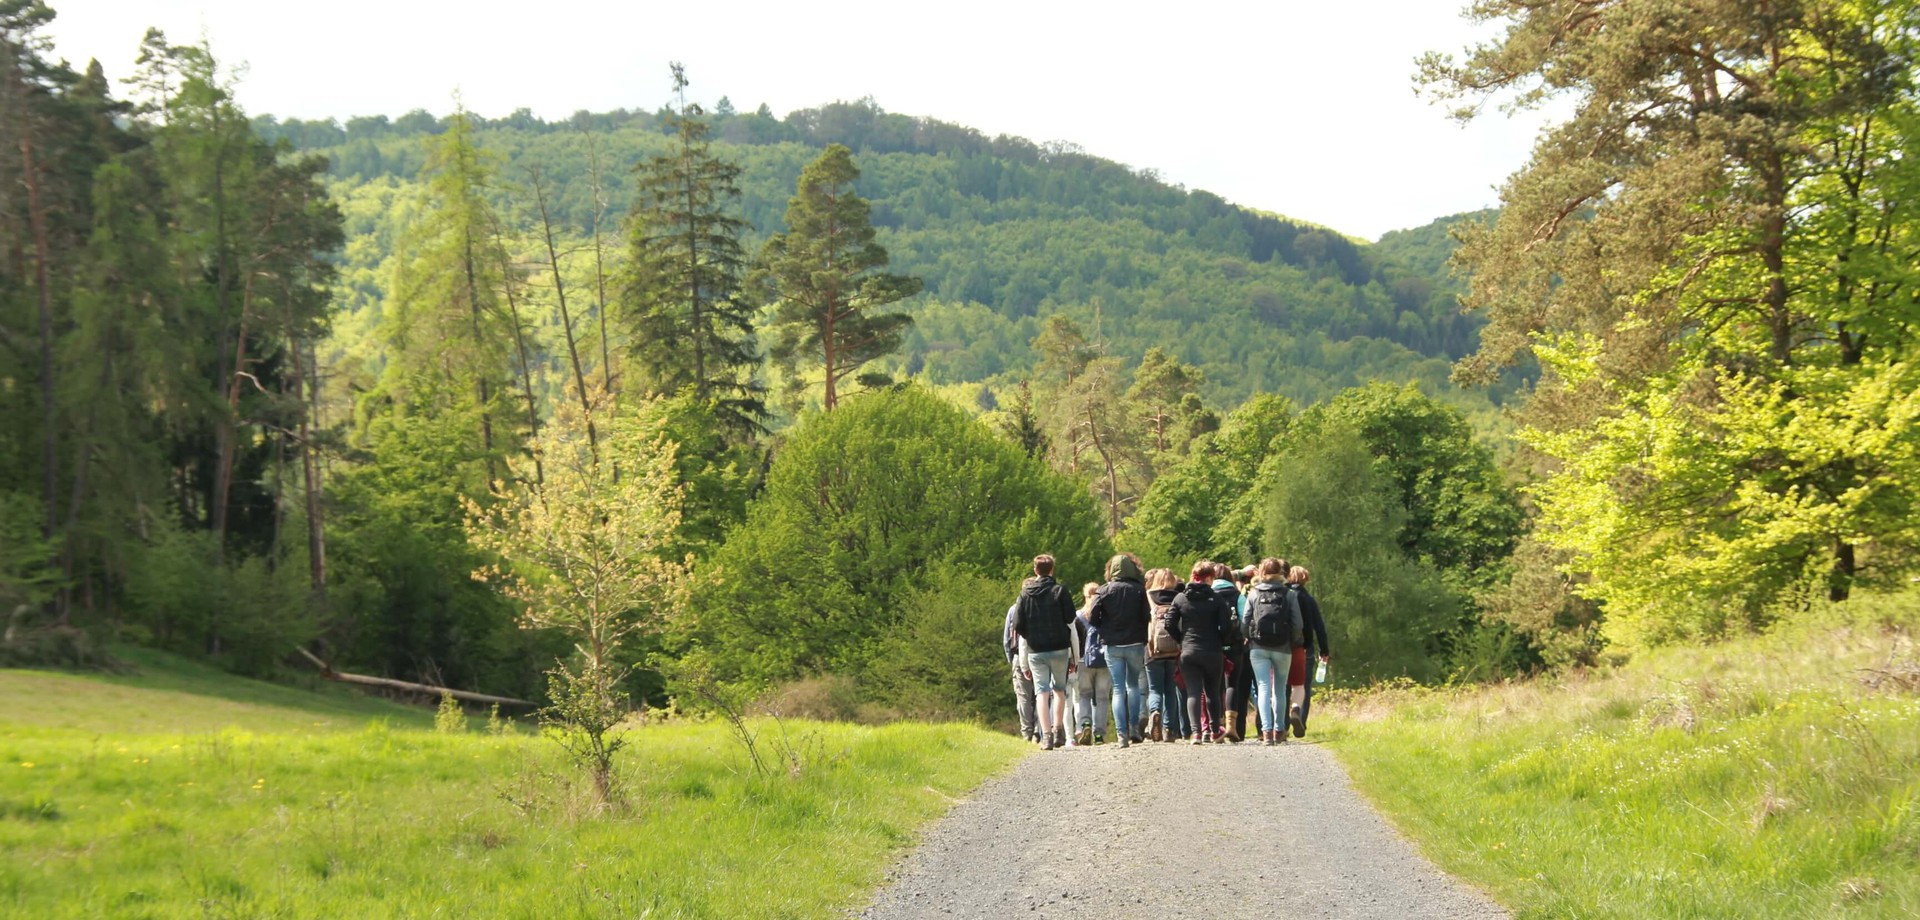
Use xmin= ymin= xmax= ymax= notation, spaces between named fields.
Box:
xmin=0 ymin=657 xmax=1023 ymax=918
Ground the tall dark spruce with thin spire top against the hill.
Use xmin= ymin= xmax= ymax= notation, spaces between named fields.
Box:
xmin=618 ymin=63 xmax=766 ymax=434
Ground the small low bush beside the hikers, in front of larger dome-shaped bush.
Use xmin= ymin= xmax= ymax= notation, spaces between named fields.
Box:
xmin=866 ymin=569 xmax=1014 ymax=722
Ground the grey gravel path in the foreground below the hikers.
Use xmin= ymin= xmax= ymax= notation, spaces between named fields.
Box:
xmin=858 ymin=741 xmax=1507 ymax=920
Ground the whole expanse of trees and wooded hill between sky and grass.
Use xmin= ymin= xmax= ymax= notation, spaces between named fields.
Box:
xmin=0 ymin=0 xmax=1920 ymax=736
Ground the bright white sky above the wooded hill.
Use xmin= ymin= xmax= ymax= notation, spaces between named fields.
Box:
xmin=52 ymin=0 xmax=1540 ymax=238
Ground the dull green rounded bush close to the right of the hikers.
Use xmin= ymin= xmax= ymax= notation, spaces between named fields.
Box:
xmin=1260 ymin=426 xmax=1461 ymax=682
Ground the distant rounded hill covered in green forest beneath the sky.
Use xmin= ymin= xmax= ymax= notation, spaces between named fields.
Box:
xmin=255 ymin=100 xmax=1480 ymax=405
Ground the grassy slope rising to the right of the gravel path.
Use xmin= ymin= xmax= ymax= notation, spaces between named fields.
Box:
xmin=1327 ymin=595 xmax=1920 ymax=918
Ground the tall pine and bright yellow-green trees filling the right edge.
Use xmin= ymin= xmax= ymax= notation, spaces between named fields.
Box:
xmin=1423 ymin=0 xmax=1920 ymax=647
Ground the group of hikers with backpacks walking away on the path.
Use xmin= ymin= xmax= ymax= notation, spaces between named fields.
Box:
xmin=1002 ymin=553 xmax=1332 ymax=751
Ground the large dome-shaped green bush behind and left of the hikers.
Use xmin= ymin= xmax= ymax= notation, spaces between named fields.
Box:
xmin=676 ymin=386 xmax=1108 ymax=682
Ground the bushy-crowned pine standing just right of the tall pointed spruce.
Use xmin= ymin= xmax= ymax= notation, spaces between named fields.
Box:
xmin=758 ymin=144 xmax=920 ymax=411
